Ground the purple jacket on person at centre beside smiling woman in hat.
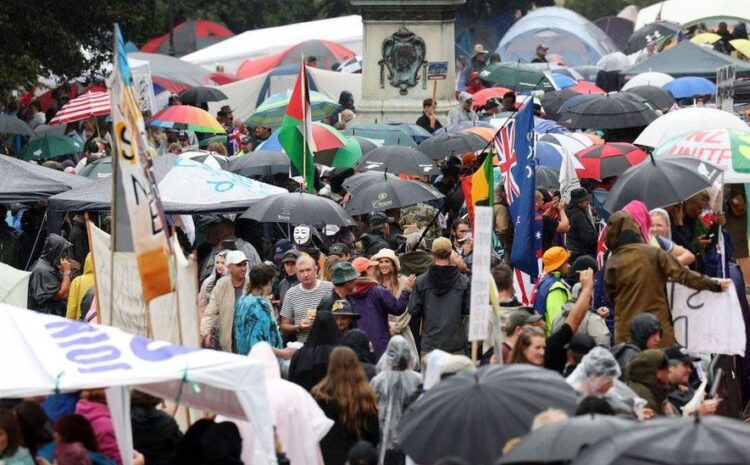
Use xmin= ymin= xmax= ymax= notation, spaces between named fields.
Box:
xmin=349 ymin=280 xmax=410 ymax=359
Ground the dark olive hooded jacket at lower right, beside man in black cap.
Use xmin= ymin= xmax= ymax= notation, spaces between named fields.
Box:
xmin=625 ymin=349 xmax=668 ymax=415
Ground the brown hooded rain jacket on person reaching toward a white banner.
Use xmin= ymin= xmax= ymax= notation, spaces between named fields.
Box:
xmin=604 ymin=211 xmax=721 ymax=347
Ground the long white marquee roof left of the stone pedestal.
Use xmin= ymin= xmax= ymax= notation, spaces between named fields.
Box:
xmin=182 ymin=15 xmax=363 ymax=72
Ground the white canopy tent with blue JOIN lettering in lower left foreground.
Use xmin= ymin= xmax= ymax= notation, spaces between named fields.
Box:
xmin=0 ymin=304 xmax=276 ymax=465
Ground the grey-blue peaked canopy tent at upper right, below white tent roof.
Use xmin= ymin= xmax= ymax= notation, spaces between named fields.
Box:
xmin=621 ymin=40 xmax=750 ymax=79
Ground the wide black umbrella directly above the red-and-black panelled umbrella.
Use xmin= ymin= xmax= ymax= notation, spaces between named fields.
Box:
xmin=558 ymin=94 xmax=659 ymax=129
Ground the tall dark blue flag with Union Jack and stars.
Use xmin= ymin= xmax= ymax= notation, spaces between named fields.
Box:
xmin=502 ymin=99 xmax=542 ymax=280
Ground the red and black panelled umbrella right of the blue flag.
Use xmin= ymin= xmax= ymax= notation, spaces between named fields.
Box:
xmin=576 ymin=142 xmax=648 ymax=179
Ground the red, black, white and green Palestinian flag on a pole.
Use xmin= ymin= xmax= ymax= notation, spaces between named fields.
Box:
xmin=279 ymin=64 xmax=315 ymax=192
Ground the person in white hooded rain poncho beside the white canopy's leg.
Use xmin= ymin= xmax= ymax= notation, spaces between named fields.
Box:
xmin=217 ymin=342 xmax=333 ymax=465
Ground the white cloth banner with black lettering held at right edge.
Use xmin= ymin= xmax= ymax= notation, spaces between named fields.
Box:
xmin=667 ymin=283 xmax=745 ymax=357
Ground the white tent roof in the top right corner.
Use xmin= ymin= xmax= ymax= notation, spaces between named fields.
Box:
xmin=635 ymin=0 xmax=750 ymax=29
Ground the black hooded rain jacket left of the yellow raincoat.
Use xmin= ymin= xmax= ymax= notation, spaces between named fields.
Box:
xmin=29 ymin=234 xmax=72 ymax=316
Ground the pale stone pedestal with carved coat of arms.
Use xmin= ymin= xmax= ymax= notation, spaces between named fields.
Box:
xmin=351 ymin=0 xmax=465 ymax=125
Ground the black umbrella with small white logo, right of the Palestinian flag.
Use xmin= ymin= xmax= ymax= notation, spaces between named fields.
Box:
xmin=346 ymin=173 xmax=444 ymax=215
